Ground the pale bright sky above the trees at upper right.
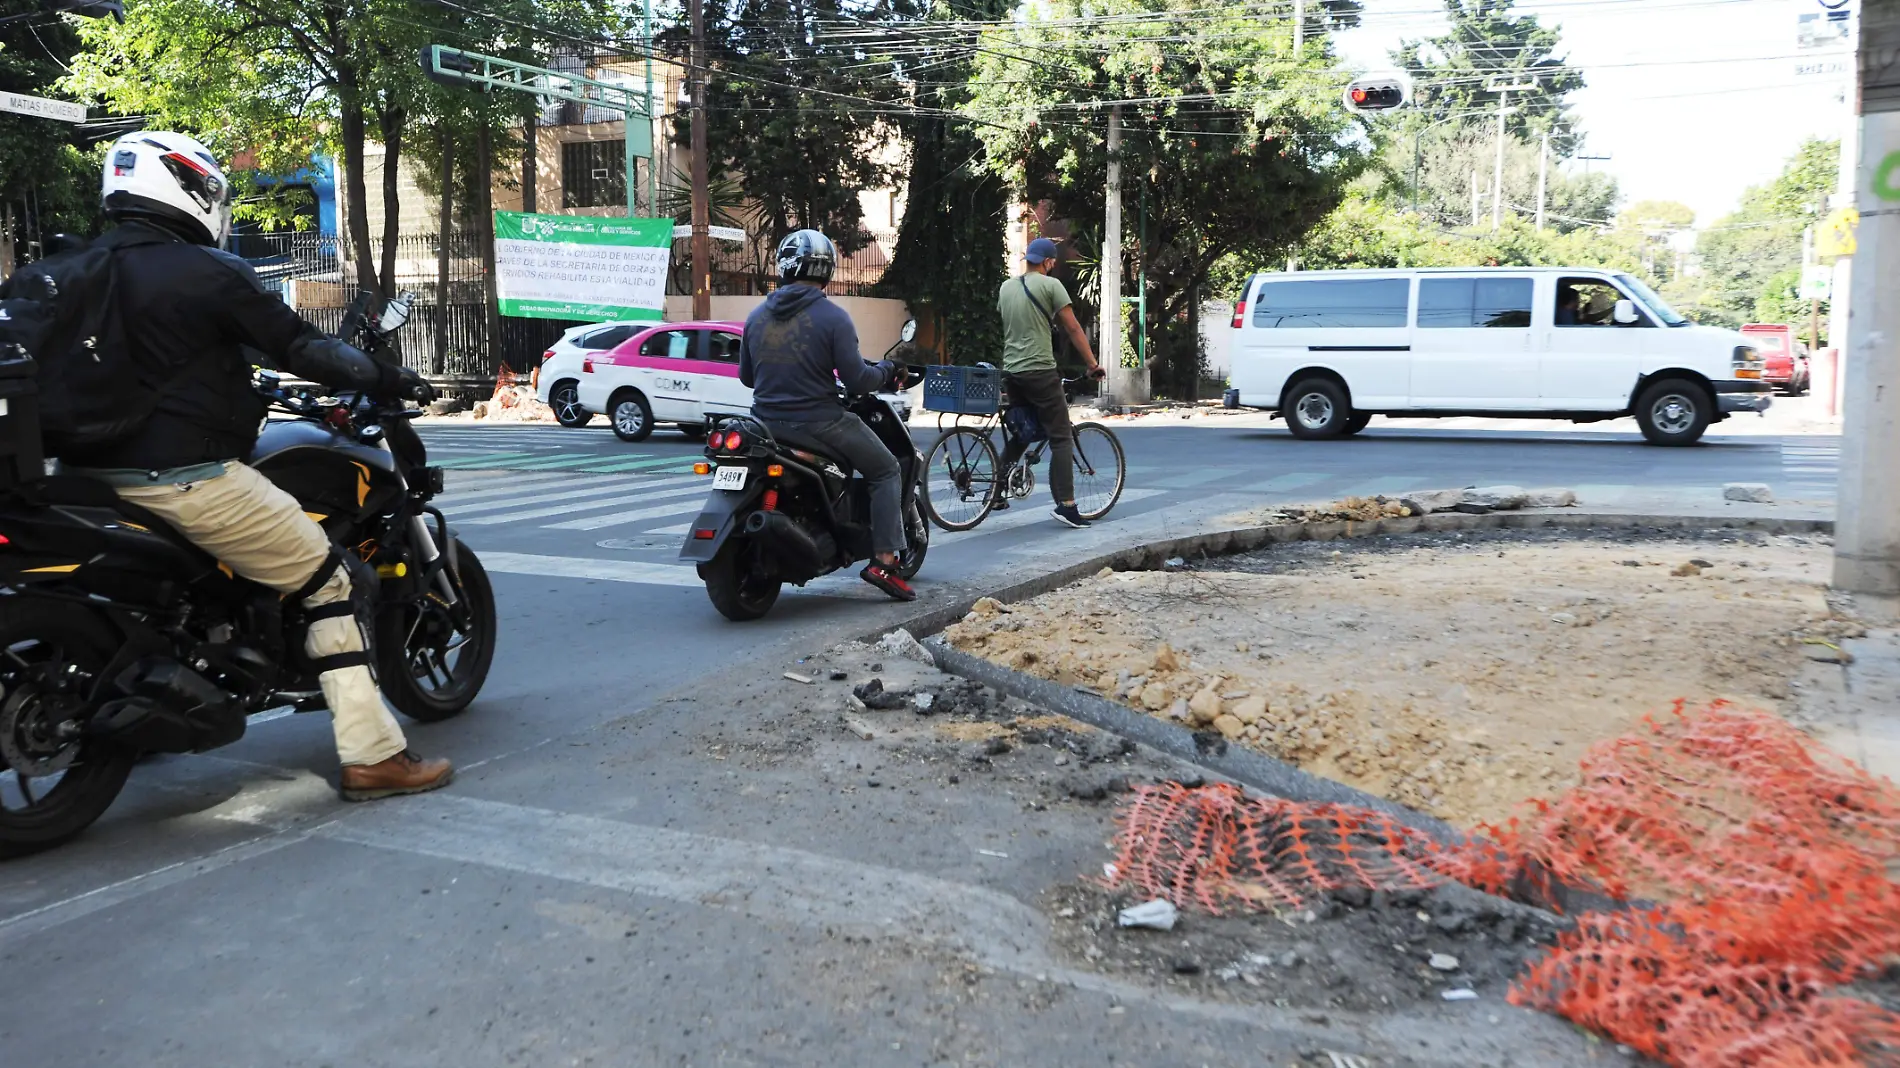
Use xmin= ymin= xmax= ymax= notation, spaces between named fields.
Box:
xmin=1338 ymin=0 xmax=1853 ymax=226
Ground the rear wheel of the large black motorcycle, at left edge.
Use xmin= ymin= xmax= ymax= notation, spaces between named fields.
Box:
xmin=0 ymin=597 xmax=139 ymax=859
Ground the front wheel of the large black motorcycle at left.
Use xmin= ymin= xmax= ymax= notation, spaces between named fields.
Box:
xmin=376 ymin=538 xmax=496 ymax=724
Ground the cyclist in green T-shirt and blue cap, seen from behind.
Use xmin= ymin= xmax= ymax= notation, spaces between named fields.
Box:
xmin=992 ymin=238 xmax=1106 ymax=526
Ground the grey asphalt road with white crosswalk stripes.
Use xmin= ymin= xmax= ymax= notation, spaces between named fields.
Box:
xmin=0 ymin=412 xmax=1837 ymax=1066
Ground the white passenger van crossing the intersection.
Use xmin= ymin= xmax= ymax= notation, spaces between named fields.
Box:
xmin=1227 ymin=268 xmax=1771 ymax=445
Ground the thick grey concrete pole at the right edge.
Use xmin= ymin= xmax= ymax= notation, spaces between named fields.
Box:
xmin=1834 ymin=0 xmax=1900 ymax=620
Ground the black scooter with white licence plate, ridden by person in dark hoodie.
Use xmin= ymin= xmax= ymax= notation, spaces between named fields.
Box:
xmin=680 ymin=325 xmax=931 ymax=621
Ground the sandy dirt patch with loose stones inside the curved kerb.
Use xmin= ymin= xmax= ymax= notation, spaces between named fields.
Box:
xmin=946 ymin=532 xmax=1854 ymax=825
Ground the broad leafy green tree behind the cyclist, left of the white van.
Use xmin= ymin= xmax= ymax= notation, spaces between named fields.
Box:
xmin=963 ymin=0 xmax=1368 ymax=390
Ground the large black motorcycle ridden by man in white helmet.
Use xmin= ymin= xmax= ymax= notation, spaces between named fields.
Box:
xmin=0 ymin=295 xmax=496 ymax=857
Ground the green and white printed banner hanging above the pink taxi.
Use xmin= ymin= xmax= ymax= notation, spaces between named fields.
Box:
xmin=494 ymin=211 xmax=673 ymax=321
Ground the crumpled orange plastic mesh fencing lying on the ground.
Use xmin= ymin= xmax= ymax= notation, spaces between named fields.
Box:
xmin=1113 ymin=703 xmax=1900 ymax=1068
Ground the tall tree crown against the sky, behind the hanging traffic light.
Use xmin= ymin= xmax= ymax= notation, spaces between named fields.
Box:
xmin=1393 ymin=0 xmax=1583 ymax=160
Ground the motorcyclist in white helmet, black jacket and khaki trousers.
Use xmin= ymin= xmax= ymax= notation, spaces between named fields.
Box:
xmin=61 ymin=131 xmax=454 ymax=800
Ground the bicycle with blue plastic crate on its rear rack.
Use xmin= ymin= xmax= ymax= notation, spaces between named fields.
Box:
xmin=923 ymin=378 xmax=1127 ymax=530
